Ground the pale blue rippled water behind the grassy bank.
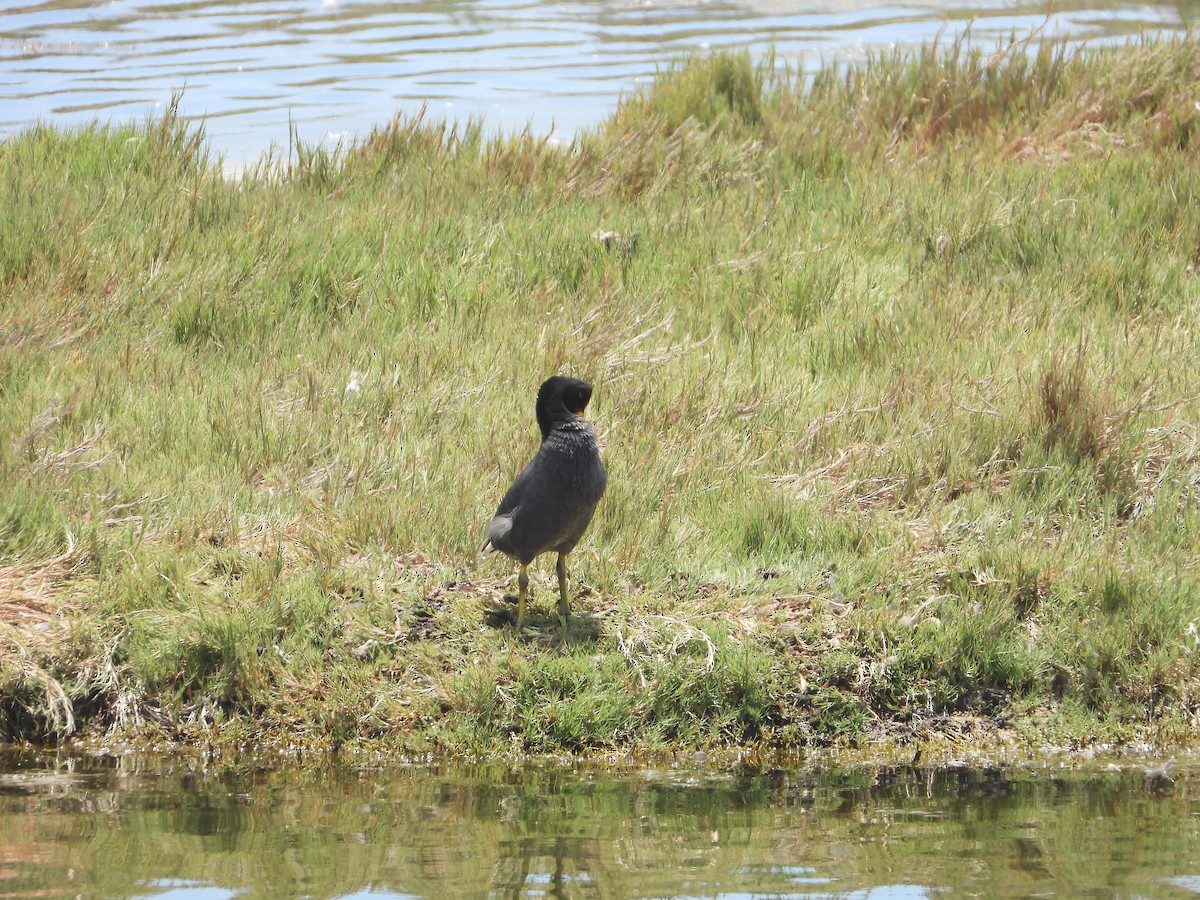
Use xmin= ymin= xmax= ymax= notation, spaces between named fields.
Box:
xmin=0 ymin=0 xmax=1196 ymax=161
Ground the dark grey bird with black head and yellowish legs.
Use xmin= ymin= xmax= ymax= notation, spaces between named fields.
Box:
xmin=484 ymin=376 xmax=608 ymax=632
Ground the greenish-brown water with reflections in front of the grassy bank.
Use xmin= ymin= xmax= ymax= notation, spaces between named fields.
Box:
xmin=0 ymin=756 xmax=1200 ymax=900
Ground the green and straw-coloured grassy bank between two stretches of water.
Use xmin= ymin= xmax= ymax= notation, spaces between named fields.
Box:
xmin=0 ymin=31 xmax=1200 ymax=754
